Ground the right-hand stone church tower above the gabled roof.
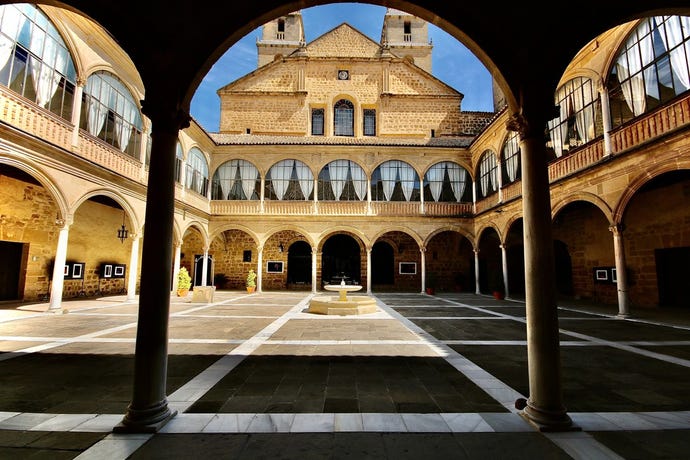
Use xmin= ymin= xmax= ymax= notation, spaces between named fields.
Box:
xmin=381 ymin=8 xmax=433 ymax=73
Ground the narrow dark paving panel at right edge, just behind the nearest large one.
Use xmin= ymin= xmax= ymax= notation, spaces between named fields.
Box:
xmin=559 ymin=318 xmax=690 ymax=341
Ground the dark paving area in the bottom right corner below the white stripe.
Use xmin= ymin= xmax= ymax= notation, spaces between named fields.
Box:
xmin=589 ymin=430 xmax=690 ymax=460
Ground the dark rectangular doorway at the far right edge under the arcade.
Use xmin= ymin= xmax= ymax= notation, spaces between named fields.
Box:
xmin=654 ymin=247 xmax=690 ymax=308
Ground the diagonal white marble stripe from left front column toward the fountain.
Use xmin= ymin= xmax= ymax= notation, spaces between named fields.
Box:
xmin=168 ymin=295 xmax=312 ymax=412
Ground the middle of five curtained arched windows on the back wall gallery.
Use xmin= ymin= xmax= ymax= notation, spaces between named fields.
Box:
xmin=318 ymin=160 xmax=367 ymax=201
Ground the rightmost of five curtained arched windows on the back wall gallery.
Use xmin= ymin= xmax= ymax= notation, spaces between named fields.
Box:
xmin=424 ymin=161 xmax=472 ymax=203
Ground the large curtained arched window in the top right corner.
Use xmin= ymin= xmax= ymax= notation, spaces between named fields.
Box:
xmin=607 ymin=16 xmax=690 ymax=128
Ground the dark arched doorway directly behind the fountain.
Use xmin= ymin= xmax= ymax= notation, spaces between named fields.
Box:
xmin=321 ymin=234 xmax=361 ymax=284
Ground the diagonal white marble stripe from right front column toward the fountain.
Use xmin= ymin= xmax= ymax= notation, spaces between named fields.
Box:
xmin=377 ymin=299 xmax=525 ymax=412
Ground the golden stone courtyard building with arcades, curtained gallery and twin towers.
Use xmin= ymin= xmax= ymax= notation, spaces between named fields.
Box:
xmin=0 ymin=5 xmax=690 ymax=314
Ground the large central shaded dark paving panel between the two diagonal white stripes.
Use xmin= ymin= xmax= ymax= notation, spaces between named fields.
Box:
xmin=188 ymin=356 xmax=506 ymax=413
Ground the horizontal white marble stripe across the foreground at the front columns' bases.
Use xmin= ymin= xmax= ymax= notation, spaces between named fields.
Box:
xmin=0 ymin=411 xmax=690 ymax=436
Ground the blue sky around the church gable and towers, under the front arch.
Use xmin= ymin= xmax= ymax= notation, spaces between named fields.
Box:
xmin=191 ymin=3 xmax=493 ymax=132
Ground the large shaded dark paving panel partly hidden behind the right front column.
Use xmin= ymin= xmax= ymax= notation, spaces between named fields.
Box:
xmin=452 ymin=345 xmax=690 ymax=412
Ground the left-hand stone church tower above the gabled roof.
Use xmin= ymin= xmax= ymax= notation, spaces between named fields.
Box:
xmin=256 ymin=11 xmax=305 ymax=67
